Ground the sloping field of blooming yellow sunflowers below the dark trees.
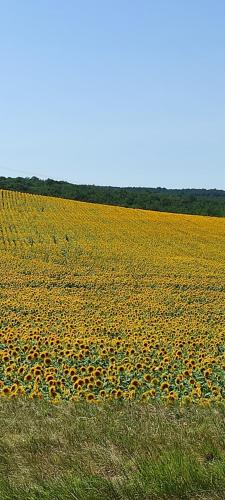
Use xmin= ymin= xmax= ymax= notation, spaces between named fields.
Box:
xmin=0 ymin=191 xmax=225 ymax=404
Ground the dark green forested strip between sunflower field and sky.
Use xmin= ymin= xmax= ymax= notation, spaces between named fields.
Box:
xmin=0 ymin=177 xmax=225 ymax=217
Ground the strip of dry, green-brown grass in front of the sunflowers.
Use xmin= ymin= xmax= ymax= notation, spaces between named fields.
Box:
xmin=0 ymin=398 xmax=225 ymax=500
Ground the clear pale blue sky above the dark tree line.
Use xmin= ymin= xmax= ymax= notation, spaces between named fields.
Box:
xmin=0 ymin=0 xmax=225 ymax=189
